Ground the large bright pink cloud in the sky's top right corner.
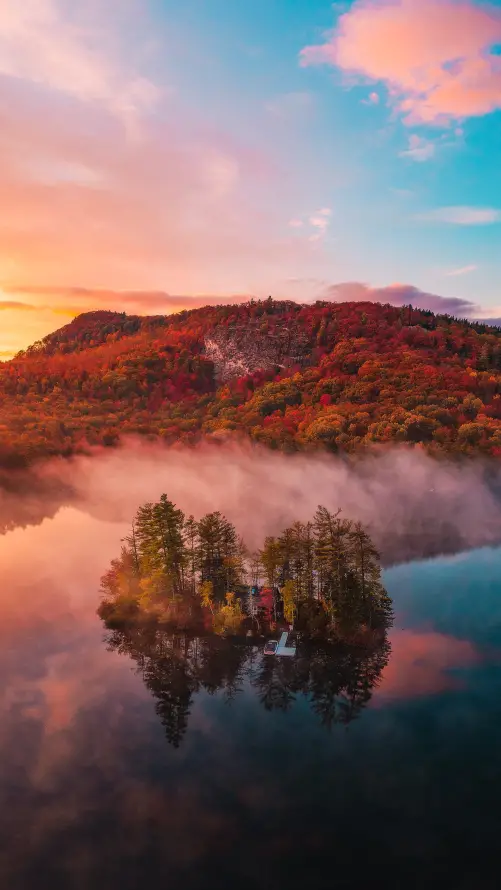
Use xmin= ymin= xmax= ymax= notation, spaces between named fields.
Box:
xmin=300 ymin=0 xmax=501 ymax=124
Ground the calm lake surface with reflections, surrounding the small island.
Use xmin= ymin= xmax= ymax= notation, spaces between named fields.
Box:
xmin=0 ymin=508 xmax=501 ymax=890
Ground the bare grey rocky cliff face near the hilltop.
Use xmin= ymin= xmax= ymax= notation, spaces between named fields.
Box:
xmin=205 ymin=320 xmax=312 ymax=383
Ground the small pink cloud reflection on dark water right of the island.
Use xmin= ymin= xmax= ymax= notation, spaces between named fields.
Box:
xmin=374 ymin=630 xmax=480 ymax=703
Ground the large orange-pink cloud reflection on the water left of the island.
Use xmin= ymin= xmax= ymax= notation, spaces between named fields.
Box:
xmin=0 ymin=509 xmax=147 ymax=806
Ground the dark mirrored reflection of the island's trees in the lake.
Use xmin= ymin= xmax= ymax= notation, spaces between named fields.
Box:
xmin=107 ymin=626 xmax=391 ymax=748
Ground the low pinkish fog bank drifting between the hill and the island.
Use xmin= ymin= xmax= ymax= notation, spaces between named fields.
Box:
xmin=4 ymin=441 xmax=501 ymax=564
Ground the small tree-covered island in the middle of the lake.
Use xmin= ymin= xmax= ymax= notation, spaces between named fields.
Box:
xmin=98 ymin=494 xmax=392 ymax=646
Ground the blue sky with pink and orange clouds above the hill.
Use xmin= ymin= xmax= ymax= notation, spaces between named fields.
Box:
xmin=0 ymin=0 xmax=501 ymax=360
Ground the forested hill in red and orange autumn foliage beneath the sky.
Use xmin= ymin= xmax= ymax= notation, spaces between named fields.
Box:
xmin=0 ymin=299 xmax=501 ymax=466
